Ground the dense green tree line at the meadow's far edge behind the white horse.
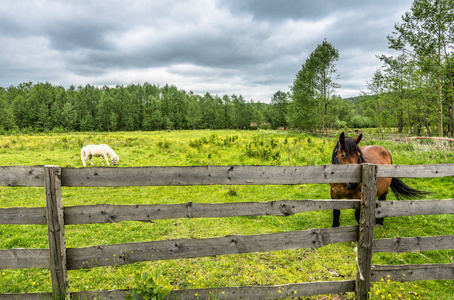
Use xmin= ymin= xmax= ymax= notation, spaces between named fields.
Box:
xmin=0 ymin=82 xmax=269 ymax=132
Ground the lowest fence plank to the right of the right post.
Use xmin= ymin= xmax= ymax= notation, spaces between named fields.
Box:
xmin=372 ymin=263 xmax=454 ymax=281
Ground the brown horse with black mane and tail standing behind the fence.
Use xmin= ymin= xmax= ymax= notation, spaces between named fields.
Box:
xmin=330 ymin=132 xmax=427 ymax=227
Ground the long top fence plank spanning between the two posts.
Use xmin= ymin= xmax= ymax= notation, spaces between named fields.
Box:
xmin=62 ymin=165 xmax=360 ymax=187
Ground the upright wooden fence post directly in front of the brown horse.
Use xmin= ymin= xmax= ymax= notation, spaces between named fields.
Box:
xmin=356 ymin=164 xmax=377 ymax=300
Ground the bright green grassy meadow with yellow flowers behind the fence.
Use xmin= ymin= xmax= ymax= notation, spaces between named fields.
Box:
xmin=0 ymin=130 xmax=454 ymax=299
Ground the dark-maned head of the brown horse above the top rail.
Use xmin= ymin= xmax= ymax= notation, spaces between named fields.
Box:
xmin=331 ymin=132 xmax=364 ymax=165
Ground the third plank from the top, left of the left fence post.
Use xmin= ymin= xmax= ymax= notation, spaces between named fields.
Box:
xmin=0 ymin=249 xmax=50 ymax=269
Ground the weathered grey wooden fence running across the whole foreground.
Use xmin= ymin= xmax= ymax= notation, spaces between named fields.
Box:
xmin=0 ymin=164 xmax=454 ymax=299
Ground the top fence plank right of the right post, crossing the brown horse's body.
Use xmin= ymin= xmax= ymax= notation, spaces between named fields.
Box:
xmin=377 ymin=164 xmax=454 ymax=178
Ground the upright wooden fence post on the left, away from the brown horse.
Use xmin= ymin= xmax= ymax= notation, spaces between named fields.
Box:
xmin=44 ymin=166 xmax=69 ymax=299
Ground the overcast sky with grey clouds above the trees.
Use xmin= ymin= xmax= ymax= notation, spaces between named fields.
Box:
xmin=0 ymin=0 xmax=413 ymax=102
